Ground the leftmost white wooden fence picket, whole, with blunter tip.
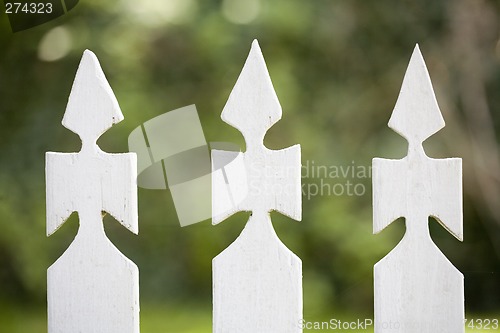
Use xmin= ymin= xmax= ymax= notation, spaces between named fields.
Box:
xmin=46 ymin=51 xmax=139 ymax=333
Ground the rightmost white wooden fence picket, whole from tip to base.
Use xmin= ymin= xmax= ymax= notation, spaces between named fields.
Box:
xmin=373 ymin=45 xmax=465 ymax=333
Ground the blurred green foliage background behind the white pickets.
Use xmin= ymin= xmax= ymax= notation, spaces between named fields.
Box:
xmin=0 ymin=0 xmax=500 ymax=333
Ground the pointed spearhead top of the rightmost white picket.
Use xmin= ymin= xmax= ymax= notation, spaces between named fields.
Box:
xmin=389 ymin=44 xmax=445 ymax=145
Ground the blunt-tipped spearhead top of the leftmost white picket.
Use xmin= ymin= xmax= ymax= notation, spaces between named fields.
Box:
xmin=62 ymin=50 xmax=123 ymax=146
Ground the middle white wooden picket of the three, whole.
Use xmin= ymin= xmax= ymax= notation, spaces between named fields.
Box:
xmin=212 ymin=41 xmax=302 ymax=333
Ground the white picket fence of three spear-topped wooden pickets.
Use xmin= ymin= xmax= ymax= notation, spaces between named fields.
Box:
xmin=46 ymin=41 xmax=465 ymax=333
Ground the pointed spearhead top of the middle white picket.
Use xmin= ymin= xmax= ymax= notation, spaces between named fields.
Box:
xmin=221 ymin=40 xmax=281 ymax=146
